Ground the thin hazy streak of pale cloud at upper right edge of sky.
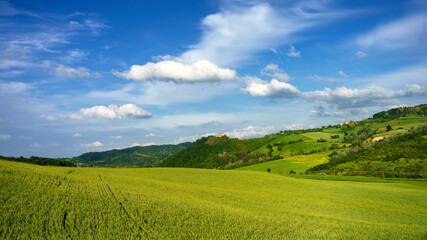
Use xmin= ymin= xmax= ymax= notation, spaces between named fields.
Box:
xmin=356 ymin=14 xmax=427 ymax=49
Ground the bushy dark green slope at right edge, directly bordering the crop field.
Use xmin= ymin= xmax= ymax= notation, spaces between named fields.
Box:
xmin=306 ymin=125 xmax=427 ymax=178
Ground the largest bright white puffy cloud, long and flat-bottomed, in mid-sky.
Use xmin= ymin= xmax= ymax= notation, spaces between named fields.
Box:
xmin=113 ymin=60 xmax=236 ymax=83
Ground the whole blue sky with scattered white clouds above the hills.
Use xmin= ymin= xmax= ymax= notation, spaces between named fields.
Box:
xmin=0 ymin=0 xmax=427 ymax=157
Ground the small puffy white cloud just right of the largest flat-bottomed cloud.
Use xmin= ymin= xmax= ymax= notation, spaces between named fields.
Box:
xmin=242 ymin=78 xmax=301 ymax=98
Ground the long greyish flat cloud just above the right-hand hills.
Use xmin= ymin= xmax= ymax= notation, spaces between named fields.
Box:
xmin=302 ymin=84 xmax=427 ymax=109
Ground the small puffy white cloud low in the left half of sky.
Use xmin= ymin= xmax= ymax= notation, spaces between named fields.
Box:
xmin=77 ymin=104 xmax=152 ymax=119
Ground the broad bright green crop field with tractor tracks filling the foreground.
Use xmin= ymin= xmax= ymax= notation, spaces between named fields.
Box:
xmin=0 ymin=158 xmax=427 ymax=239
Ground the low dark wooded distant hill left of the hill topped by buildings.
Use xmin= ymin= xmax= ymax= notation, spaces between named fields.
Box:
xmin=70 ymin=142 xmax=190 ymax=167
